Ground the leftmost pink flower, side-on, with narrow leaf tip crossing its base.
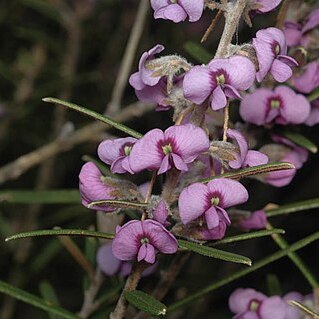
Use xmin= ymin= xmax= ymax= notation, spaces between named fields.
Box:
xmin=79 ymin=162 xmax=116 ymax=212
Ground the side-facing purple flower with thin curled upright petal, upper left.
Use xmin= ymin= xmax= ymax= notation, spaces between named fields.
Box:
xmin=129 ymin=44 xmax=164 ymax=91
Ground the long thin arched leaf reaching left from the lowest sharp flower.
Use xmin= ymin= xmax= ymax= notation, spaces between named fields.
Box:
xmin=5 ymin=229 xmax=114 ymax=241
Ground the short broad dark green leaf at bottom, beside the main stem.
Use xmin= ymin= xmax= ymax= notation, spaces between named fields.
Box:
xmin=125 ymin=290 xmax=166 ymax=316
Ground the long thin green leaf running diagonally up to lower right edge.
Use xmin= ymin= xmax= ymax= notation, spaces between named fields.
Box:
xmin=167 ymin=231 xmax=319 ymax=312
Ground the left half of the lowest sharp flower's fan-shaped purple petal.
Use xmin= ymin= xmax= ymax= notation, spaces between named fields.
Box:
xmin=112 ymin=220 xmax=144 ymax=261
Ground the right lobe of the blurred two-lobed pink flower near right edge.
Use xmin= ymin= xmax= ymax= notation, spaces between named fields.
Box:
xmin=275 ymin=85 xmax=311 ymax=124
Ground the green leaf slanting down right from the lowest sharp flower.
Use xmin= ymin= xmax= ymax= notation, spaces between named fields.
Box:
xmin=178 ymin=240 xmax=252 ymax=266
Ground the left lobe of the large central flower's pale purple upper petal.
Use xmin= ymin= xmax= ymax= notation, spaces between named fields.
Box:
xmin=128 ymin=129 xmax=164 ymax=173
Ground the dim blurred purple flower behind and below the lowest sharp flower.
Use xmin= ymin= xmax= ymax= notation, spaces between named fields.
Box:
xmin=96 ymin=243 xmax=157 ymax=277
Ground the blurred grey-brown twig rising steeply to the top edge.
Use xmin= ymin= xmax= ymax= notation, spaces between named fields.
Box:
xmin=105 ymin=0 xmax=149 ymax=114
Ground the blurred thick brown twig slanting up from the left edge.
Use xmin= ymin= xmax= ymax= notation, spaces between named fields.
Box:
xmin=0 ymin=102 xmax=154 ymax=185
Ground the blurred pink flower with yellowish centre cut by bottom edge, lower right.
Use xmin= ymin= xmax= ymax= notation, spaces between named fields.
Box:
xmin=229 ymin=288 xmax=286 ymax=319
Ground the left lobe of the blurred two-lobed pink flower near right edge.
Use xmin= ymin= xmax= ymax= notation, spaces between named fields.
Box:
xmin=239 ymin=89 xmax=273 ymax=125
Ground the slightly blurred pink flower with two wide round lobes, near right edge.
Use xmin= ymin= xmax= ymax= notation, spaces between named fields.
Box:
xmin=240 ymin=86 xmax=310 ymax=125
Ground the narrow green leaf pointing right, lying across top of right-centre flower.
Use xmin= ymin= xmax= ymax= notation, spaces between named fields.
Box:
xmin=202 ymin=162 xmax=295 ymax=183
